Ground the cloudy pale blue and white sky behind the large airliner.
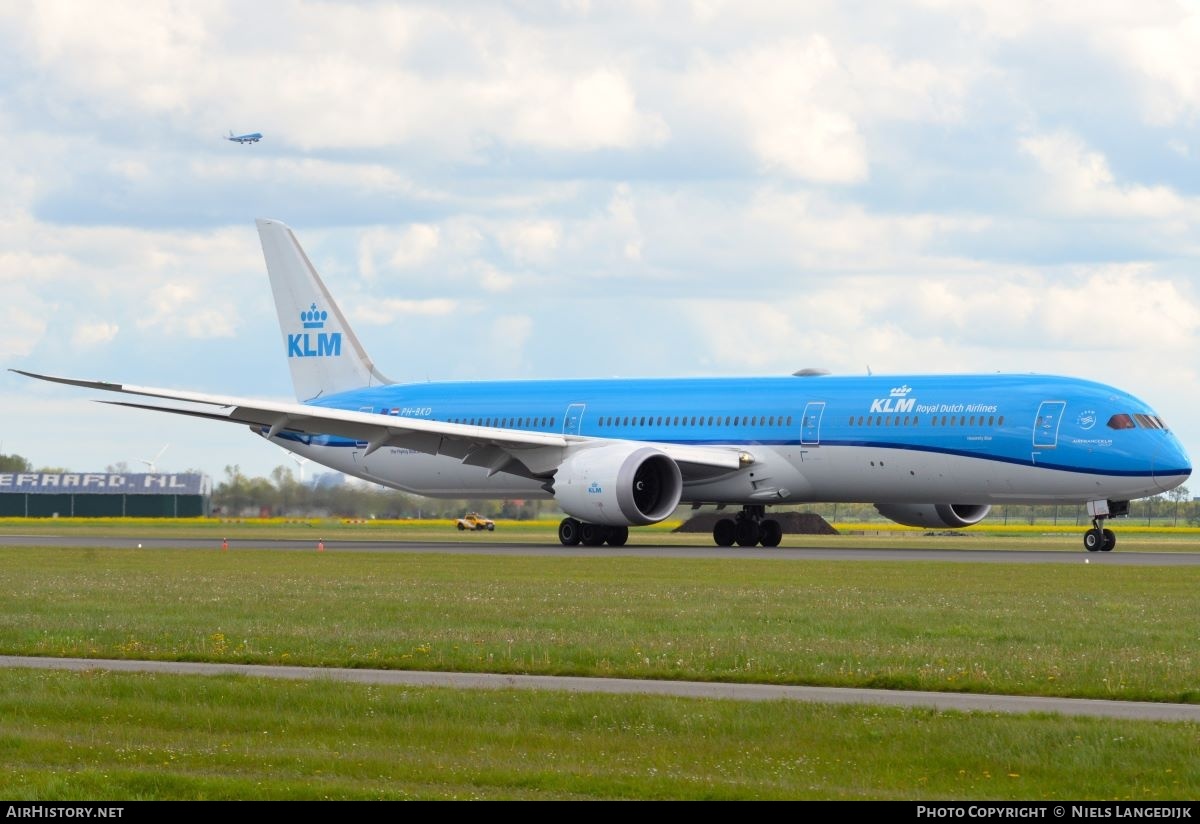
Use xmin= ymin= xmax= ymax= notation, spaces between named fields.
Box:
xmin=0 ymin=0 xmax=1200 ymax=481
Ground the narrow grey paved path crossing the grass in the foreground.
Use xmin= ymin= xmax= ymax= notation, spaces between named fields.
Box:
xmin=0 ymin=656 xmax=1200 ymax=723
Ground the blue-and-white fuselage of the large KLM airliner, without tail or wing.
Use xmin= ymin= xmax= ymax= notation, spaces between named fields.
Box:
xmin=274 ymin=374 xmax=1192 ymax=503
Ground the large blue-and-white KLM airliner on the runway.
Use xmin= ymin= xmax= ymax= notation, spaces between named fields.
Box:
xmin=14 ymin=219 xmax=1192 ymax=552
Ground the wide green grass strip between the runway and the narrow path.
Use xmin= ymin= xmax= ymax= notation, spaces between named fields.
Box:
xmin=0 ymin=548 xmax=1200 ymax=702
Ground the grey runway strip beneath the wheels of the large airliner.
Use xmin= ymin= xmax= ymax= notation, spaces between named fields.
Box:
xmin=0 ymin=535 xmax=1200 ymax=566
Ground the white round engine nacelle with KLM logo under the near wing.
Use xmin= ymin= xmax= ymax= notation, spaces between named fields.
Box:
xmin=554 ymin=444 xmax=683 ymax=527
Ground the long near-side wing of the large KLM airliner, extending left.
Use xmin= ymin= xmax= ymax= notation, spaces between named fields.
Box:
xmin=10 ymin=369 xmax=751 ymax=481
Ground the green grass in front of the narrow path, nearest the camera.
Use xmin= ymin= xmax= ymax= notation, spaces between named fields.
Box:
xmin=0 ymin=670 xmax=1200 ymax=800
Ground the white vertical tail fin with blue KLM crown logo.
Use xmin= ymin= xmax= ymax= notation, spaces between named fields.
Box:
xmin=254 ymin=217 xmax=392 ymax=401
